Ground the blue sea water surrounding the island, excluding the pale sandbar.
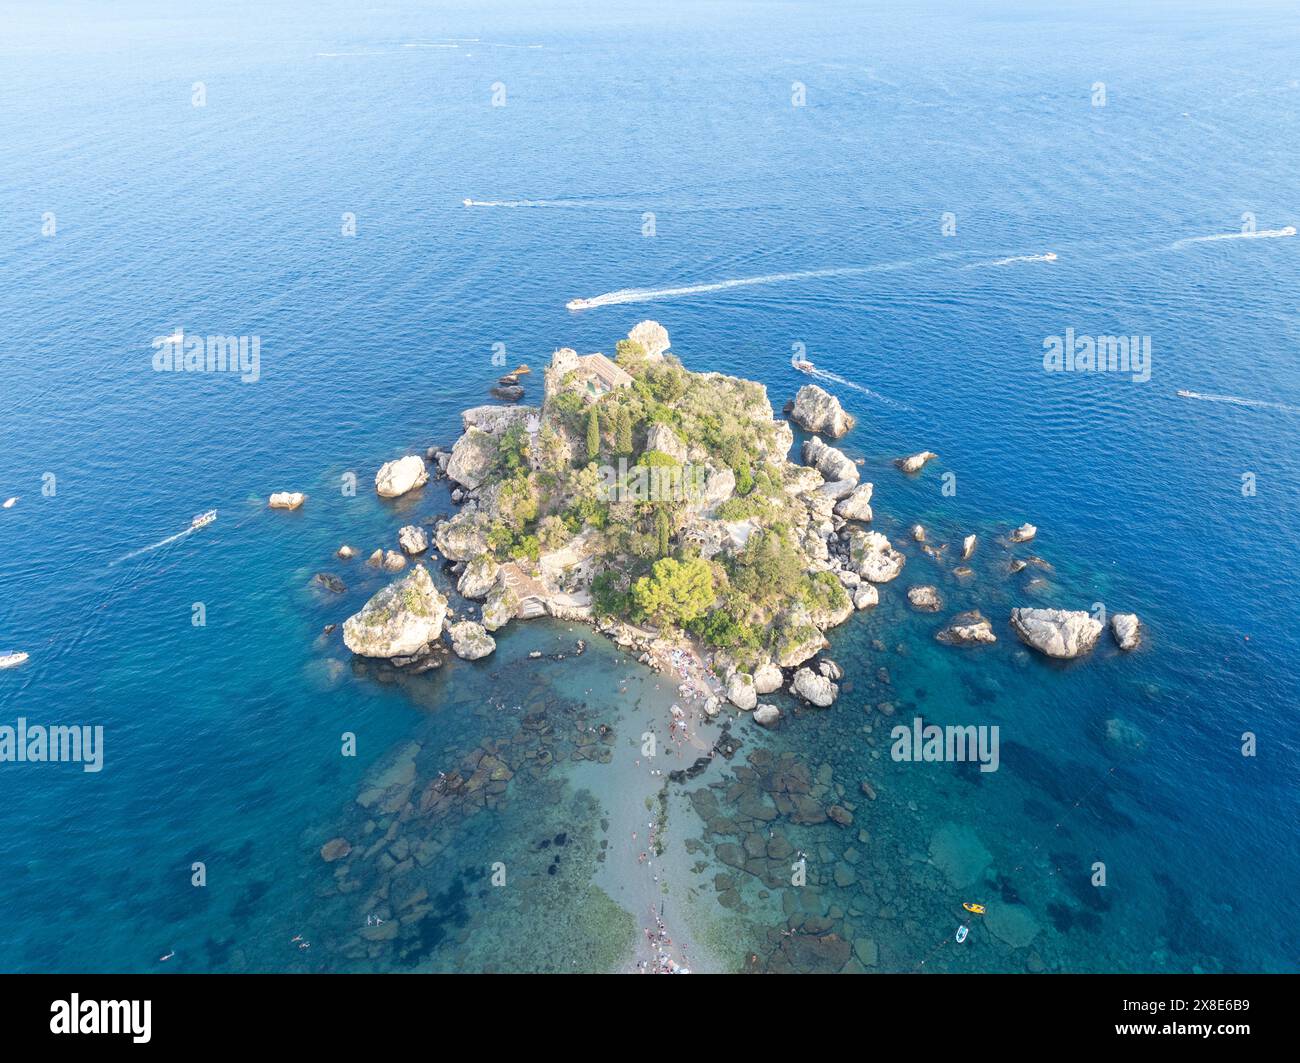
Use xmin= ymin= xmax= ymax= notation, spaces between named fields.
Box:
xmin=0 ymin=0 xmax=1300 ymax=971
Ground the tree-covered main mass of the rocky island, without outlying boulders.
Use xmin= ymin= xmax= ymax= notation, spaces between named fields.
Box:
xmin=436 ymin=321 xmax=870 ymax=668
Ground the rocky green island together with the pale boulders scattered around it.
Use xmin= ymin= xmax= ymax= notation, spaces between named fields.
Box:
xmin=343 ymin=321 xmax=1138 ymax=701
